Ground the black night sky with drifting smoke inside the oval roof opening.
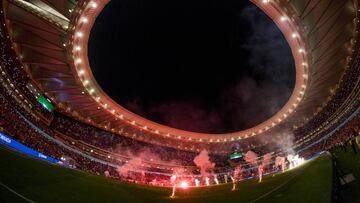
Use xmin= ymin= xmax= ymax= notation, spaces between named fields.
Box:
xmin=89 ymin=0 xmax=295 ymax=133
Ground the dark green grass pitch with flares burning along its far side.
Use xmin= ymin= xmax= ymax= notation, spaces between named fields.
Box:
xmin=0 ymin=147 xmax=332 ymax=203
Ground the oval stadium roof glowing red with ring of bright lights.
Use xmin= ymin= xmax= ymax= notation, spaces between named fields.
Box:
xmin=2 ymin=0 xmax=359 ymax=152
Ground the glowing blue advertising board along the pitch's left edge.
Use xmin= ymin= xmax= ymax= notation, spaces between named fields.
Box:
xmin=0 ymin=132 xmax=62 ymax=165
